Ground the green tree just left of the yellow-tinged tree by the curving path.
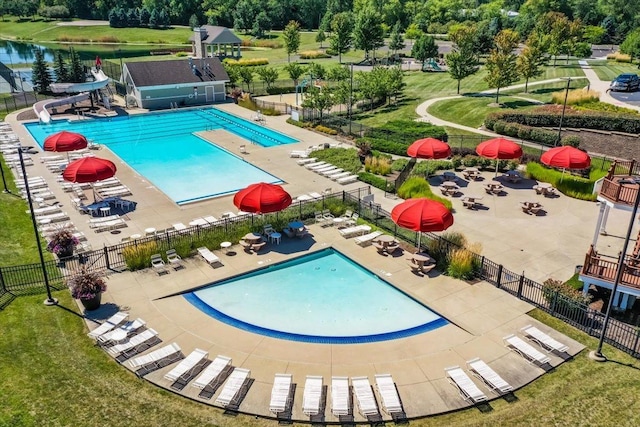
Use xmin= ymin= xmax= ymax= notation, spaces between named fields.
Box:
xmin=446 ymin=26 xmax=479 ymax=94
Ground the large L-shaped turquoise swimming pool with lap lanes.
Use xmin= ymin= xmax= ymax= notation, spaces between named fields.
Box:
xmin=25 ymin=108 xmax=296 ymax=204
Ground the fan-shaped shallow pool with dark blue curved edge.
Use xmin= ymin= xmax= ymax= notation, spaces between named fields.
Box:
xmin=184 ymin=249 xmax=448 ymax=344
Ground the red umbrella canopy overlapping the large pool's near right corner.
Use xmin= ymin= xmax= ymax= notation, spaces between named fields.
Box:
xmin=233 ymin=182 xmax=291 ymax=213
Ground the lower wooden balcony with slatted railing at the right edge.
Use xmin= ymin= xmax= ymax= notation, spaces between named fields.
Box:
xmin=580 ymin=246 xmax=640 ymax=289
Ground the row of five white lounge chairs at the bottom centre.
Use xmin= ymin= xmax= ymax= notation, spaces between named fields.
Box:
xmin=269 ymin=374 xmax=403 ymax=417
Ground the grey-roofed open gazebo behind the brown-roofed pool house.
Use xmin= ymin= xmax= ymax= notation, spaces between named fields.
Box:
xmin=190 ymin=25 xmax=242 ymax=58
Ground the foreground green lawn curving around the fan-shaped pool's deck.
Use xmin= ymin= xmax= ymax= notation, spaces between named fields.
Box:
xmin=0 ymin=291 xmax=640 ymax=427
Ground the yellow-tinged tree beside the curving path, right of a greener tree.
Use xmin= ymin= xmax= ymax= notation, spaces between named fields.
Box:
xmin=484 ymin=30 xmax=519 ymax=104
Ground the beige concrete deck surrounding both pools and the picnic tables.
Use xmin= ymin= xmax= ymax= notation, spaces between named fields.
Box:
xmin=6 ymin=104 xmax=629 ymax=422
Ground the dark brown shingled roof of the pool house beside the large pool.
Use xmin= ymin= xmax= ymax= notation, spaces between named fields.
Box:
xmin=125 ymin=58 xmax=229 ymax=87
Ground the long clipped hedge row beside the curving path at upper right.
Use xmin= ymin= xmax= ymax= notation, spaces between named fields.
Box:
xmin=484 ymin=107 xmax=640 ymax=134
